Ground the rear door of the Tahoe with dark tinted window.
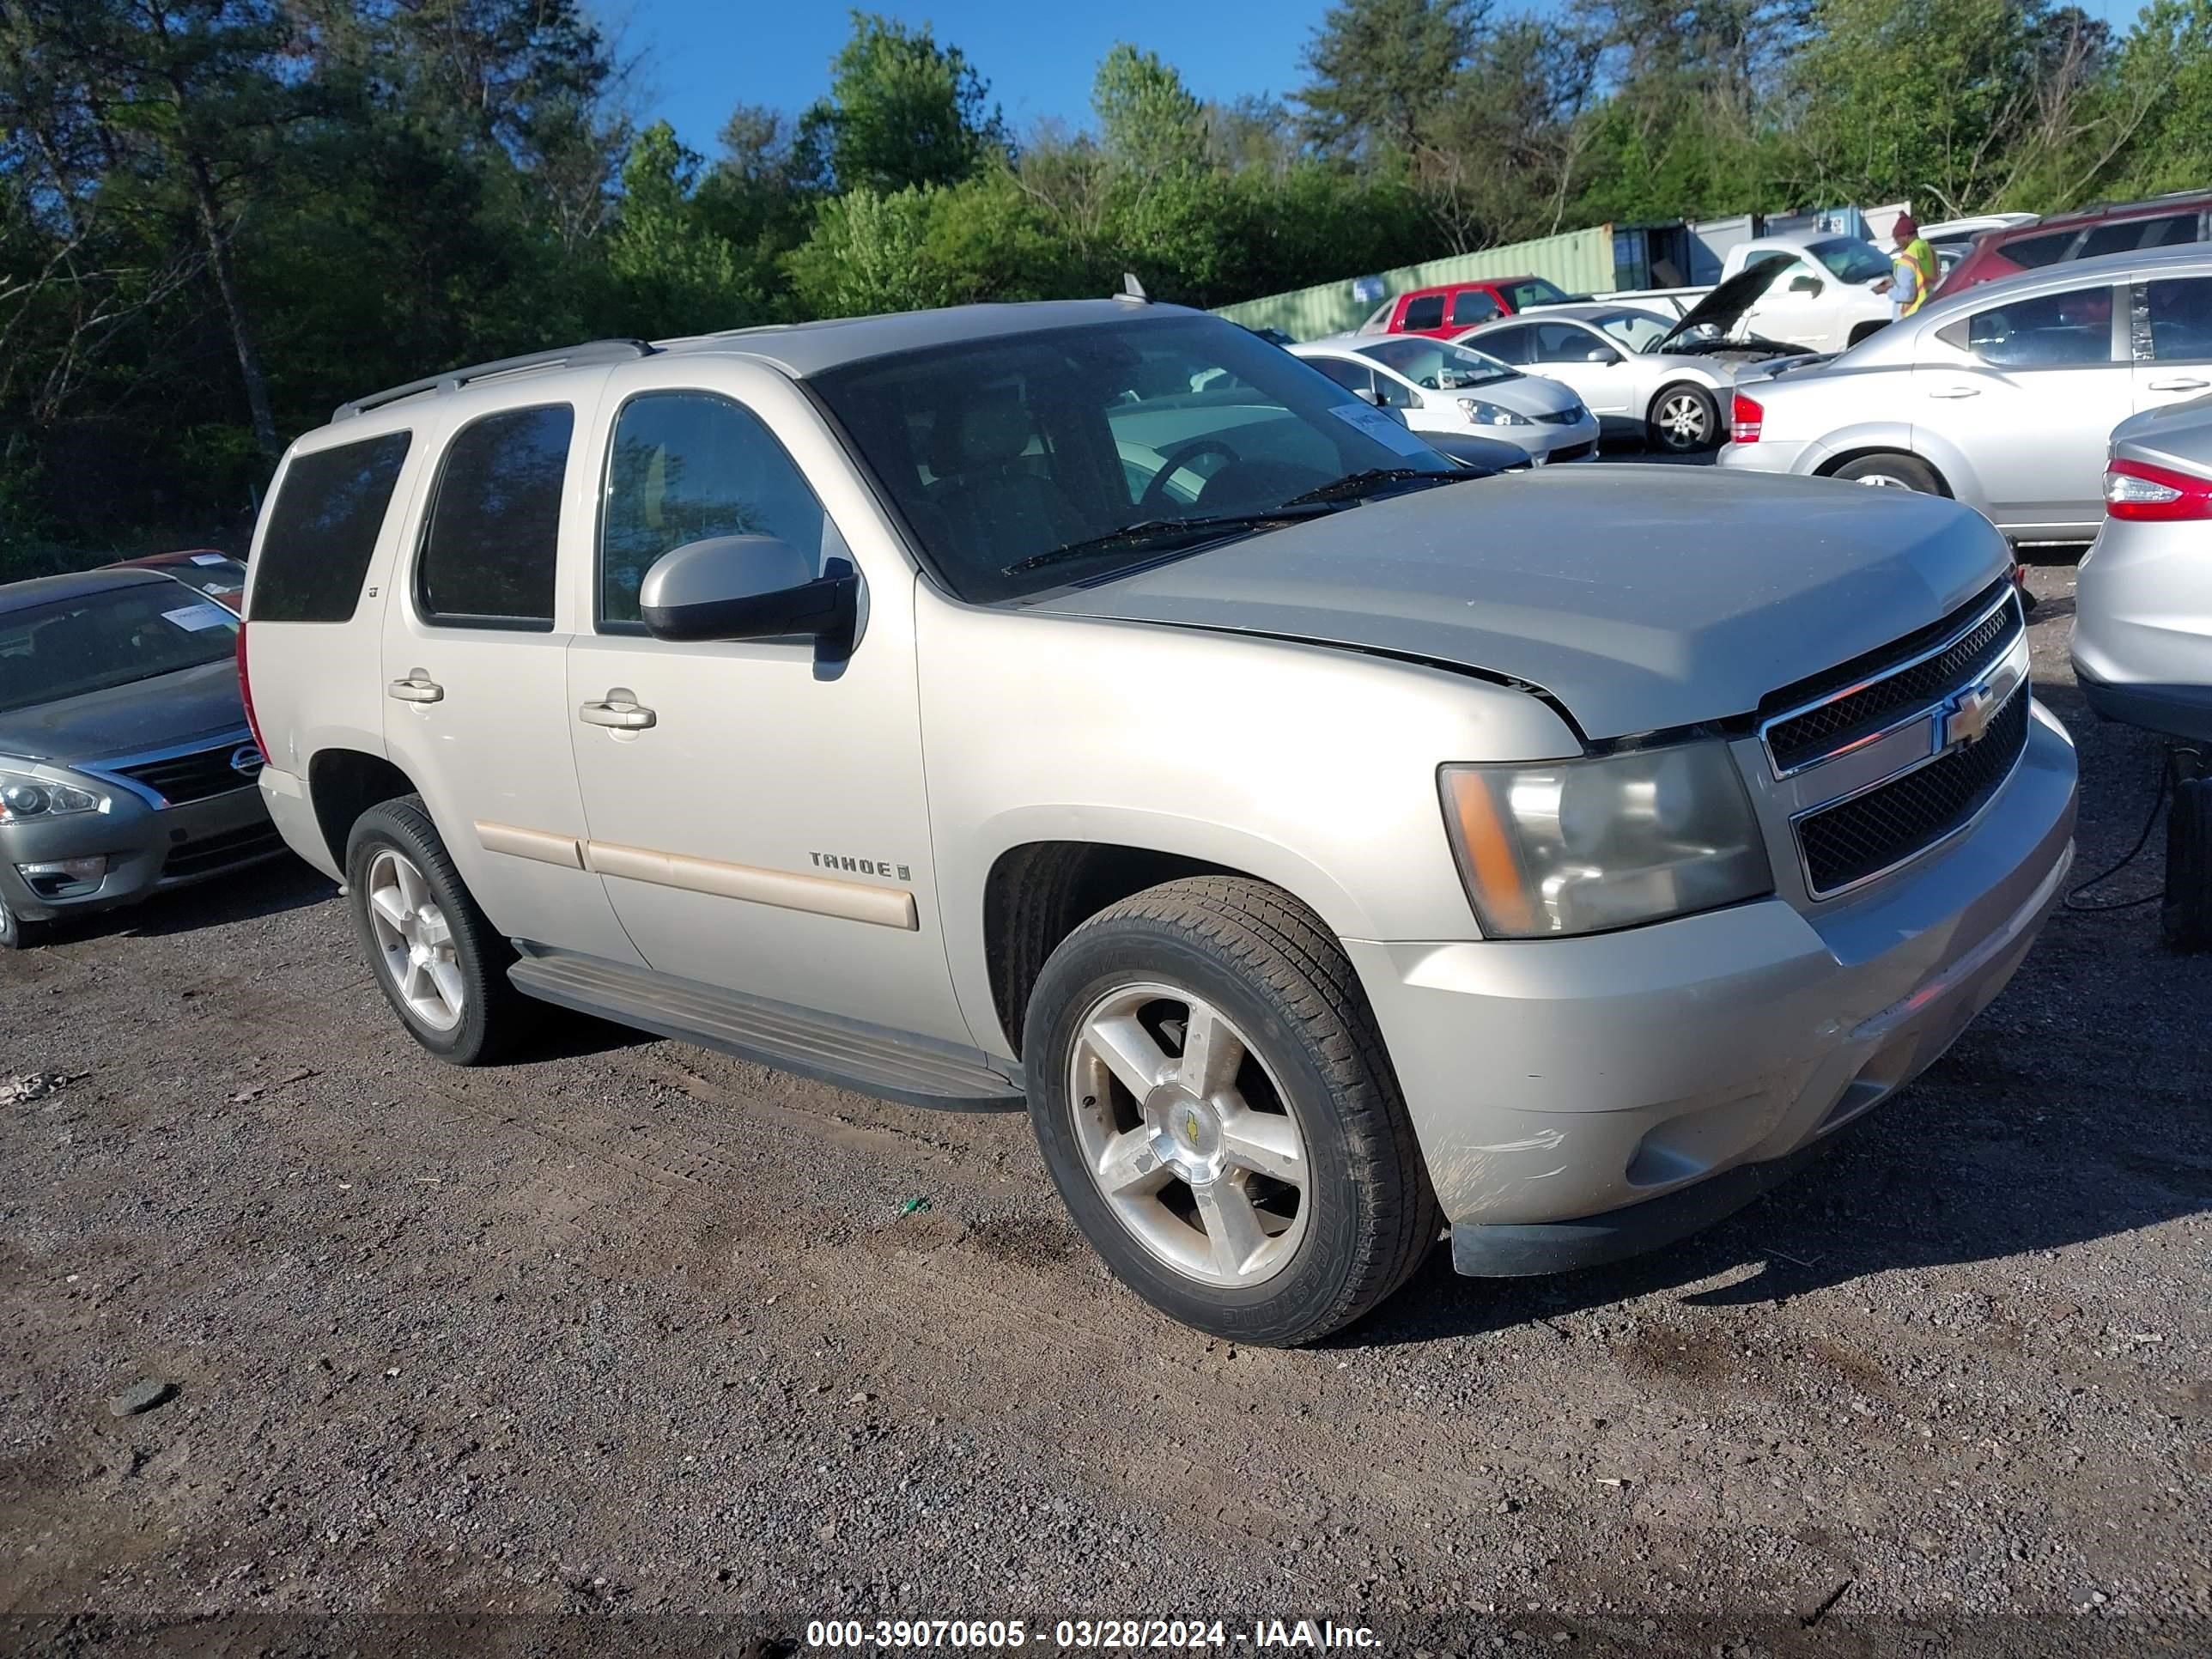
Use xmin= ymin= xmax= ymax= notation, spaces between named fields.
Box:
xmin=383 ymin=400 xmax=639 ymax=963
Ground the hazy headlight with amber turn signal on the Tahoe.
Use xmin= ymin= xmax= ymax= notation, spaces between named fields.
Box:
xmin=1440 ymin=744 xmax=1774 ymax=938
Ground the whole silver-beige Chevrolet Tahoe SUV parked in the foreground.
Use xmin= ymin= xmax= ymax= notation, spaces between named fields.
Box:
xmin=241 ymin=301 xmax=2075 ymax=1343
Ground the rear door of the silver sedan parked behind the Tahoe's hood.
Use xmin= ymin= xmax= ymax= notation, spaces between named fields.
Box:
xmin=1913 ymin=283 xmax=2135 ymax=538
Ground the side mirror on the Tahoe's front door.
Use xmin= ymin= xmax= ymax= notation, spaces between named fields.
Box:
xmin=637 ymin=535 xmax=860 ymax=661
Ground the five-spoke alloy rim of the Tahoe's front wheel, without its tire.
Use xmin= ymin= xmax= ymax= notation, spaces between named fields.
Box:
xmin=1068 ymin=984 xmax=1312 ymax=1287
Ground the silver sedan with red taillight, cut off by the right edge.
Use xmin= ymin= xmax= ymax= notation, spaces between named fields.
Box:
xmin=1721 ymin=246 xmax=2212 ymax=542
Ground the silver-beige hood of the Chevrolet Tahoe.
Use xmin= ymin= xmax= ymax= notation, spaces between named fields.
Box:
xmin=1036 ymin=467 xmax=2011 ymax=738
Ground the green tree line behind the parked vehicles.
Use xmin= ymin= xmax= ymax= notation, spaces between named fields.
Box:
xmin=0 ymin=0 xmax=2212 ymax=575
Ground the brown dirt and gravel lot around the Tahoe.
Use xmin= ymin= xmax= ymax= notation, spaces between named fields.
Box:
xmin=0 ymin=564 xmax=2212 ymax=1655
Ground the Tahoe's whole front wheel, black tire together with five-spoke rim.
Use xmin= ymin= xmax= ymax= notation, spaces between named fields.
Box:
xmin=1022 ymin=876 xmax=1443 ymax=1347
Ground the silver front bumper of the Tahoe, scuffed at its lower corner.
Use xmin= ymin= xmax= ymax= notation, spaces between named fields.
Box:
xmin=1345 ymin=708 xmax=2075 ymax=1274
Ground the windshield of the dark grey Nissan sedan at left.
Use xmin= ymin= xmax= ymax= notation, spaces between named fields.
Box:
xmin=0 ymin=580 xmax=239 ymax=710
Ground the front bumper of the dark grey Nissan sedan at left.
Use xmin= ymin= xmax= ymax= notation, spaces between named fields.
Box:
xmin=0 ymin=783 xmax=283 ymax=922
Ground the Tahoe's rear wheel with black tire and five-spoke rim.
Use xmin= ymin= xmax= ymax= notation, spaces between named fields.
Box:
xmin=345 ymin=794 xmax=535 ymax=1066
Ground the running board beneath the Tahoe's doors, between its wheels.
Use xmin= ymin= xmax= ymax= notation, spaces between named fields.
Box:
xmin=507 ymin=945 xmax=1029 ymax=1113
